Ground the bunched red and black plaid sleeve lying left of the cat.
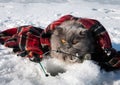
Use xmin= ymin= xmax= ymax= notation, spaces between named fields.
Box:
xmin=0 ymin=26 xmax=50 ymax=58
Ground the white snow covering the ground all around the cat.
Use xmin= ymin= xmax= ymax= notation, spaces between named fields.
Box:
xmin=0 ymin=0 xmax=120 ymax=85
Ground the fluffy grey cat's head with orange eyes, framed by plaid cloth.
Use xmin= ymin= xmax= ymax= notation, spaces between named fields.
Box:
xmin=51 ymin=21 xmax=94 ymax=62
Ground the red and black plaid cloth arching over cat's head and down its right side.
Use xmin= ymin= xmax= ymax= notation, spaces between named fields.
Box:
xmin=44 ymin=15 xmax=120 ymax=69
